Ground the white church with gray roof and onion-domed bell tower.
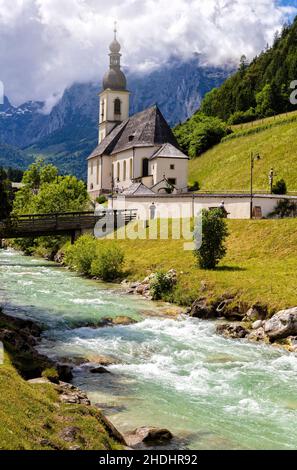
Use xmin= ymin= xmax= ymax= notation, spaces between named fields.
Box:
xmin=88 ymin=29 xmax=189 ymax=200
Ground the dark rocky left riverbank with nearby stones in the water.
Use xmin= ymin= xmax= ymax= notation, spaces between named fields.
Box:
xmin=0 ymin=309 xmax=175 ymax=450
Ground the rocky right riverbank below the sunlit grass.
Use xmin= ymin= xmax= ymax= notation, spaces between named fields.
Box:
xmin=122 ymin=269 xmax=297 ymax=352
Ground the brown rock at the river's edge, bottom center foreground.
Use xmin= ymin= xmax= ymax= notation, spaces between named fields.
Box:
xmin=126 ymin=426 xmax=173 ymax=447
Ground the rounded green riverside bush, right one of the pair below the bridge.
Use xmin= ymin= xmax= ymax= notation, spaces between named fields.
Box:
xmin=91 ymin=244 xmax=124 ymax=281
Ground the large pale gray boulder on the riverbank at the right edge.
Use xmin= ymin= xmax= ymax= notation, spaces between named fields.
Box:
xmin=264 ymin=307 xmax=297 ymax=341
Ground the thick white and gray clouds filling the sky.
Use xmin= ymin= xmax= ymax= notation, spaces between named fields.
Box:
xmin=0 ymin=0 xmax=297 ymax=109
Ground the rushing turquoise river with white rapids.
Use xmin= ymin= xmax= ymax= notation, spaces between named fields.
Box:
xmin=0 ymin=250 xmax=297 ymax=450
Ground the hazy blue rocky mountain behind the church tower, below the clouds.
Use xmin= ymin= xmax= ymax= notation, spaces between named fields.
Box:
xmin=0 ymin=57 xmax=231 ymax=178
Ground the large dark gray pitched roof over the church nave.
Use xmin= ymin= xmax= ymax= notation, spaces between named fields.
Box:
xmin=89 ymin=106 xmax=179 ymax=158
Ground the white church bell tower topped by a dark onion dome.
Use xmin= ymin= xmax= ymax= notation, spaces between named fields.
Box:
xmin=99 ymin=23 xmax=130 ymax=144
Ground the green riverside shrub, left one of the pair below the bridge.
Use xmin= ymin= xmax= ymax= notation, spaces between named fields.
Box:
xmin=65 ymin=235 xmax=96 ymax=276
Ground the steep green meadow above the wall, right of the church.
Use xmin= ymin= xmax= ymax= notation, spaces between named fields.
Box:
xmin=189 ymin=112 xmax=297 ymax=191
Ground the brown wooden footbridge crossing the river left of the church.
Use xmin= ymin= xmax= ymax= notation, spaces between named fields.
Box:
xmin=0 ymin=209 xmax=137 ymax=242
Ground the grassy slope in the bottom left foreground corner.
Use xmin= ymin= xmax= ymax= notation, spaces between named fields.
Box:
xmin=0 ymin=350 xmax=120 ymax=450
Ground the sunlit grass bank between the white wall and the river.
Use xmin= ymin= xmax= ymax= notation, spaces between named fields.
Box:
xmin=98 ymin=219 xmax=297 ymax=309
